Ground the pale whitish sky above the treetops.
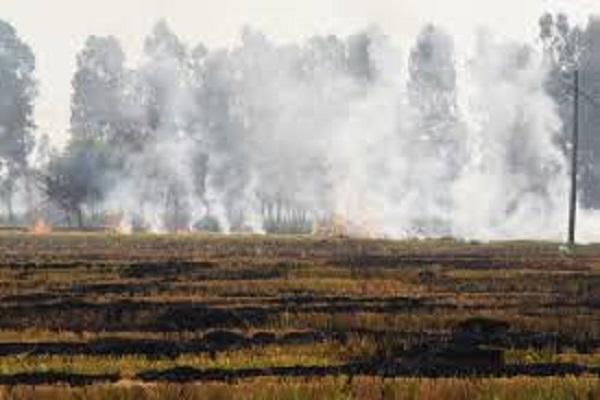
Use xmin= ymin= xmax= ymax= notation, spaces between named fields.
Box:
xmin=0 ymin=0 xmax=600 ymax=143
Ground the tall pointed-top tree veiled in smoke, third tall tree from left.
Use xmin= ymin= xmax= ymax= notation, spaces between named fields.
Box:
xmin=137 ymin=20 xmax=201 ymax=231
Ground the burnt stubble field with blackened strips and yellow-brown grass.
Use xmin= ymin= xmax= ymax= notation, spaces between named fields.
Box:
xmin=0 ymin=232 xmax=600 ymax=400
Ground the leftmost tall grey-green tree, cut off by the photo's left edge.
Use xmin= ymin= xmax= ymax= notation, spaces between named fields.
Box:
xmin=0 ymin=20 xmax=37 ymax=221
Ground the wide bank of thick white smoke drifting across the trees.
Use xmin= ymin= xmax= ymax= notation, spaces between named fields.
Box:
xmin=96 ymin=26 xmax=580 ymax=239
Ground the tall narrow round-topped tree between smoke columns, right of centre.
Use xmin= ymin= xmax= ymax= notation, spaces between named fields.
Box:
xmin=404 ymin=25 xmax=464 ymax=233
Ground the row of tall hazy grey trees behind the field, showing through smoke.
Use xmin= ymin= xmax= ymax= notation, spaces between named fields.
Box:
xmin=0 ymin=14 xmax=600 ymax=233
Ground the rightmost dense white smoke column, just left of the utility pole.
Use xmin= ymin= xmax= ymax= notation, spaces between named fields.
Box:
xmin=453 ymin=35 xmax=568 ymax=238
